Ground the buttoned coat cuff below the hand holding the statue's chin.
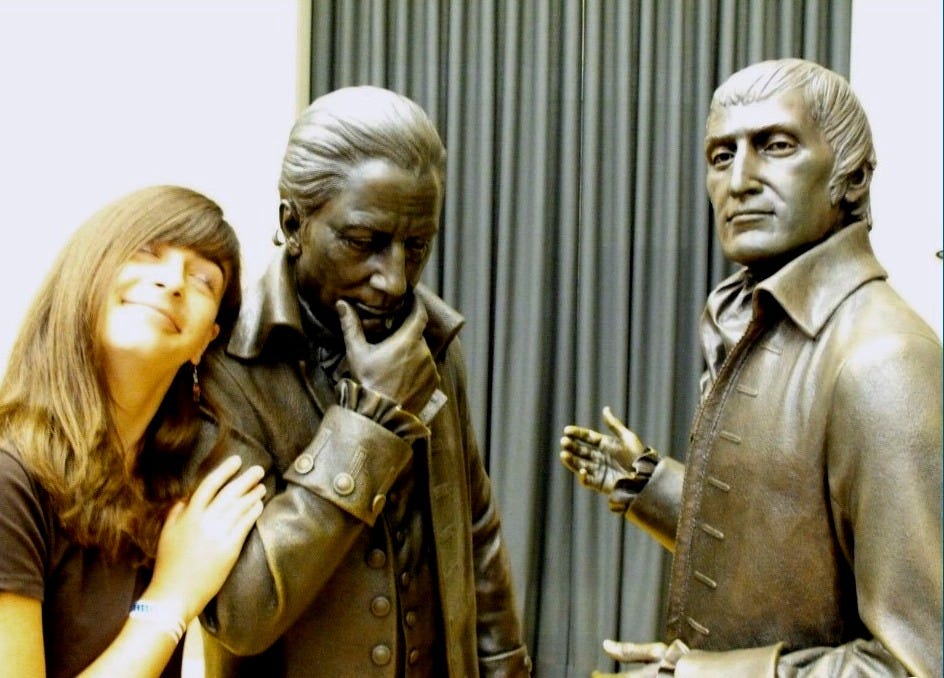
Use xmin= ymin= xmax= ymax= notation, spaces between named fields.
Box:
xmin=284 ymin=405 xmax=413 ymax=526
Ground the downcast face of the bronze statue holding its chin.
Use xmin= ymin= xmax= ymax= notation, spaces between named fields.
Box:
xmin=295 ymin=160 xmax=442 ymax=341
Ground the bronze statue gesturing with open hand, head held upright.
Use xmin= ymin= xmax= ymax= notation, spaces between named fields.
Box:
xmin=561 ymin=59 xmax=942 ymax=676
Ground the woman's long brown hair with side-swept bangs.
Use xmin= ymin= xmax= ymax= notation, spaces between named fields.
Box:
xmin=0 ymin=186 xmax=240 ymax=561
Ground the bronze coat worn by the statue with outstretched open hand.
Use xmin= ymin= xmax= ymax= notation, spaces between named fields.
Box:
xmin=629 ymin=224 xmax=942 ymax=676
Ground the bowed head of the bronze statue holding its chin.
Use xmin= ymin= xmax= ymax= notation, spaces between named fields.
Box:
xmin=279 ymin=87 xmax=446 ymax=340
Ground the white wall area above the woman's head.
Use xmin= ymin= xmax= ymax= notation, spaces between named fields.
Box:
xmin=0 ymin=0 xmax=298 ymax=369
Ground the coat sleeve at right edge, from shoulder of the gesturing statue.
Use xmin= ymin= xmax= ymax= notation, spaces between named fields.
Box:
xmin=827 ymin=333 xmax=944 ymax=676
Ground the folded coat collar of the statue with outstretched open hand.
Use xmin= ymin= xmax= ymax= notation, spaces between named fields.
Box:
xmin=754 ymin=222 xmax=888 ymax=338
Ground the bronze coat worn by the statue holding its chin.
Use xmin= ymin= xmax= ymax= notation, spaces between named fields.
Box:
xmin=190 ymin=257 xmax=530 ymax=678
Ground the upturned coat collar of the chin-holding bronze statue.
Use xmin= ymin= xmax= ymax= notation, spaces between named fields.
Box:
xmin=226 ymin=249 xmax=465 ymax=360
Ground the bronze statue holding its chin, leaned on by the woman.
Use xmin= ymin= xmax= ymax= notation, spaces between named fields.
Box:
xmin=191 ymin=87 xmax=530 ymax=677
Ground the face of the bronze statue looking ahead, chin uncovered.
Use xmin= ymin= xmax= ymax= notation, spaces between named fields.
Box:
xmin=705 ymin=91 xmax=842 ymax=271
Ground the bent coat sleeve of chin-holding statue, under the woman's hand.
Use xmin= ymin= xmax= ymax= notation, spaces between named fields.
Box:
xmin=194 ymin=361 xmax=412 ymax=655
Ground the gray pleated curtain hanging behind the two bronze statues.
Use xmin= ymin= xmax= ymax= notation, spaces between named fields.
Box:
xmin=311 ymin=0 xmax=852 ymax=678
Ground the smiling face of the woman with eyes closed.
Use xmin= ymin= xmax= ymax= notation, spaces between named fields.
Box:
xmin=100 ymin=243 xmax=226 ymax=371
